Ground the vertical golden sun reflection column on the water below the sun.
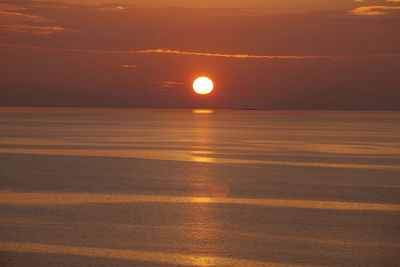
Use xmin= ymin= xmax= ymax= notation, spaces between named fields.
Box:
xmin=185 ymin=110 xmax=225 ymax=258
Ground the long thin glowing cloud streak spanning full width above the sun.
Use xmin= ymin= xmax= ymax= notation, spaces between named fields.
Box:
xmin=0 ymin=43 xmax=400 ymax=61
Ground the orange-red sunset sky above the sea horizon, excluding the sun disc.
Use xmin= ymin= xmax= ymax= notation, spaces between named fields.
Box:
xmin=0 ymin=0 xmax=400 ymax=110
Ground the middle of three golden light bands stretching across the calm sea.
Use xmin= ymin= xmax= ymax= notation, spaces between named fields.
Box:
xmin=0 ymin=192 xmax=400 ymax=212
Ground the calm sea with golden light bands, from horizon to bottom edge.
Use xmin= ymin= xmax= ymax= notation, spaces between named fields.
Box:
xmin=0 ymin=108 xmax=400 ymax=266
